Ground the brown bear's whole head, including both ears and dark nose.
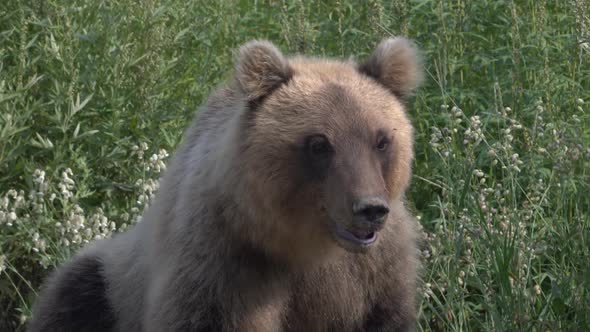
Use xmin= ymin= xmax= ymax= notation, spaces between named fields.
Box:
xmin=224 ymin=38 xmax=420 ymax=261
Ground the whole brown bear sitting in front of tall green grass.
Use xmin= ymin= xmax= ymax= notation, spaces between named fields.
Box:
xmin=29 ymin=37 xmax=421 ymax=331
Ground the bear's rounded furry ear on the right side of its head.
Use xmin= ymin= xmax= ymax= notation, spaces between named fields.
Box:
xmin=359 ymin=37 xmax=422 ymax=99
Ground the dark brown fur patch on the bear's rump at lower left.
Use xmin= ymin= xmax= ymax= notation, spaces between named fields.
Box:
xmin=29 ymin=257 xmax=116 ymax=331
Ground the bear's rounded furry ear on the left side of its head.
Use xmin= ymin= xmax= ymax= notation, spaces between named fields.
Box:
xmin=235 ymin=40 xmax=293 ymax=101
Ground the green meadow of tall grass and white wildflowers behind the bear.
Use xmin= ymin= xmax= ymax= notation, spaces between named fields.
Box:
xmin=0 ymin=0 xmax=590 ymax=331
